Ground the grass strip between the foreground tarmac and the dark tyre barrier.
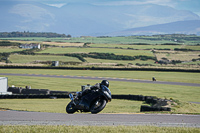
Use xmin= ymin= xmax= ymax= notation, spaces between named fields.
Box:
xmin=0 ymin=99 xmax=200 ymax=114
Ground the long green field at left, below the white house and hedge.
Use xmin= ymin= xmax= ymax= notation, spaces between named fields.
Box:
xmin=9 ymin=55 xmax=81 ymax=63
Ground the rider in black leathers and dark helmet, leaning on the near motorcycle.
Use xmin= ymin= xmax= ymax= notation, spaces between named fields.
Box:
xmin=78 ymin=80 xmax=109 ymax=98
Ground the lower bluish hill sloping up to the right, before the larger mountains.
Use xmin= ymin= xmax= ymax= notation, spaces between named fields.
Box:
xmin=107 ymin=20 xmax=200 ymax=36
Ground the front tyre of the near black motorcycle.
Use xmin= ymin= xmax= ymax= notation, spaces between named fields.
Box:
xmin=90 ymin=99 xmax=106 ymax=114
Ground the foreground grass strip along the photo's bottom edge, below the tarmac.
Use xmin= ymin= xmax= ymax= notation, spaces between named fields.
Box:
xmin=0 ymin=125 xmax=200 ymax=133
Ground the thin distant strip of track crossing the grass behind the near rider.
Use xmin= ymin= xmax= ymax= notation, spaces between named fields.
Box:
xmin=0 ymin=73 xmax=200 ymax=87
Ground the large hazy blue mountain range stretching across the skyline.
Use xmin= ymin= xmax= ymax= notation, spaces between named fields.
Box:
xmin=0 ymin=0 xmax=200 ymax=36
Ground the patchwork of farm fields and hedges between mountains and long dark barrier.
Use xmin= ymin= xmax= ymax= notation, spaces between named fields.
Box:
xmin=0 ymin=34 xmax=200 ymax=70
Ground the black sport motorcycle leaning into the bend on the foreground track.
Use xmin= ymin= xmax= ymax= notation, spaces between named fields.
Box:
xmin=66 ymin=85 xmax=112 ymax=114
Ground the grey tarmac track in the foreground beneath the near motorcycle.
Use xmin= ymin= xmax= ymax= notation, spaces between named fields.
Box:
xmin=0 ymin=110 xmax=200 ymax=128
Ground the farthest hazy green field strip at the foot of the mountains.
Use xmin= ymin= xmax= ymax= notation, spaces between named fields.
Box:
xmin=1 ymin=35 xmax=200 ymax=45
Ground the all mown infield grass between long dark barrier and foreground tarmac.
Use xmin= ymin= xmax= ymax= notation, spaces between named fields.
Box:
xmin=0 ymin=69 xmax=200 ymax=113
